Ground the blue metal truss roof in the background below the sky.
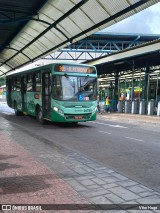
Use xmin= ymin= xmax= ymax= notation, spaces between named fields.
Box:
xmin=42 ymin=32 xmax=160 ymax=60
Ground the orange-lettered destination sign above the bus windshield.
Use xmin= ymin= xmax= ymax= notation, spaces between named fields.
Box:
xmin=54 ymin=64 xmax=96 ymax=74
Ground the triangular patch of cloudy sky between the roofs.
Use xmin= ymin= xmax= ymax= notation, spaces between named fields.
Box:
xmin=101 ymin=3 xmax=160 ymax=34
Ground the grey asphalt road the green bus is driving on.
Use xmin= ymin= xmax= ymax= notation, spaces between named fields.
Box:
xmin=0 ymin=103 xmax=160 ymax=192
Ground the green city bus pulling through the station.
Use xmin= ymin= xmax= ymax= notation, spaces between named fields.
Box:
xmin=6 ymin=63 xmax=97 ymax=124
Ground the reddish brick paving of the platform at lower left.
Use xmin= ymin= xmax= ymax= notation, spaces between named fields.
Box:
xmin=0 ymin=124 xmax=87 ymax=212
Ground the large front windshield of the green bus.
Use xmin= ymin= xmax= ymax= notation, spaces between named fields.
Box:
xmin=52 ymin=75 xmax=97 ymax=101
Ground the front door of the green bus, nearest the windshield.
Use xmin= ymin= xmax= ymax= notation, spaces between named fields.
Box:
xmin=42 ymin=72 xmax=51 ymax=116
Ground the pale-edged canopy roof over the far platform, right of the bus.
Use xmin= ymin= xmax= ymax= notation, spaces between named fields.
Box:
xmin=85 ymin=39 xmax=160 ymax=75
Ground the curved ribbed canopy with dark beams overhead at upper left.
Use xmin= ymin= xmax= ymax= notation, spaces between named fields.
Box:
xmin=0 ymin=0 xmax=159 ymax=76
